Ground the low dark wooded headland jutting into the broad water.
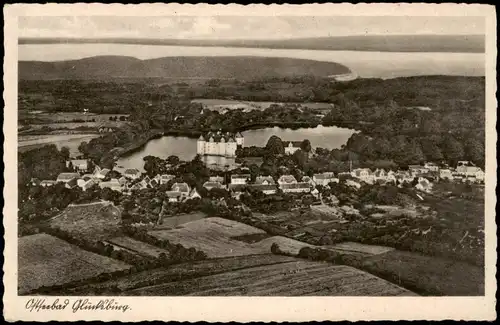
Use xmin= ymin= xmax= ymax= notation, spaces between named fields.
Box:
xmin=19 ymin=56 xmax=350 ymax=80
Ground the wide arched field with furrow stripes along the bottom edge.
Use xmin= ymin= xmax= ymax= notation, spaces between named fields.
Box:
xmin=55 ymin=254 xmax=415 ymax=296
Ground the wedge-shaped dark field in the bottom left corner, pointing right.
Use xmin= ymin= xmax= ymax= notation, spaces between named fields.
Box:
xmin=18 ymin=234 xmax=129 ymax=294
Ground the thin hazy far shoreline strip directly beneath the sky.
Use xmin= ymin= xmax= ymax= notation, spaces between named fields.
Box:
xmin=19 ymin=35 xmax=485 ymax=53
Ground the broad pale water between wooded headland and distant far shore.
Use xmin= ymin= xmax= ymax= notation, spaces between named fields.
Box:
xmin=18 ymin=44 xmax=485 ymax=78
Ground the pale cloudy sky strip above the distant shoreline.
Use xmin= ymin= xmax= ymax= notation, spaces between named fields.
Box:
xmin=19 ymin=16 xmax=485 ymax=39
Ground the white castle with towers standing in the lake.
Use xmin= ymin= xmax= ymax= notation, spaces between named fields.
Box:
xmin=196 ymin=131 xmax=243 ymax=157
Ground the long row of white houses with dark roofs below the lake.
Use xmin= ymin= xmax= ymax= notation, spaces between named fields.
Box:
xmin=31 ymin=142 xmax=485 ymax=202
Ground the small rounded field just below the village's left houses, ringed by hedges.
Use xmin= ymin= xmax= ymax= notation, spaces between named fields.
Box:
xmin=49 ymin=202 xmax=121 ymax=241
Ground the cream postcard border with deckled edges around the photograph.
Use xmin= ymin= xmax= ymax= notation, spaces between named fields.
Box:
xmin=3 ymin=4 xmax=497 ymax=322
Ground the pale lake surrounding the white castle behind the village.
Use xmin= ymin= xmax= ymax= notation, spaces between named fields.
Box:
xmin=117 ymin=125 xmax=356 ymax=170
